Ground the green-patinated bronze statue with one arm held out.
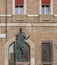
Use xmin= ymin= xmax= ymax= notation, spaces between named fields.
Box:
xmin=15 ymin=28 xmax=30 ymax=62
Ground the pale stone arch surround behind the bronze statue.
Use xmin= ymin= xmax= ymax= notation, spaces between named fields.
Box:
xmin=5 ymin=37 xmax=35 ymax=65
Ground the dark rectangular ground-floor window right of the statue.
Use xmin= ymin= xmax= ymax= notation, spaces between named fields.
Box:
xmin=42 ymin=43 xmax=53 ymax=63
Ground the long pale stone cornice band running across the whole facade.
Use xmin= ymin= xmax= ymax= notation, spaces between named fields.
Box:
xmin=0 ymin=23 xmax=57 ymax=26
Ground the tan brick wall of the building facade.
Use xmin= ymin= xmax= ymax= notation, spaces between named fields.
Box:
xmin=0 ymin=0 xmax=57 ymax=65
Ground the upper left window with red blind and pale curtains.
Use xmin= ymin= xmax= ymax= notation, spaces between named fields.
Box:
xmin=15 ymin=0 xmax=24 ymax=14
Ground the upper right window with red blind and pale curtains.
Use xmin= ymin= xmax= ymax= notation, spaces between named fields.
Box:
xmin=41 ymin=0 xmax=50 ymax=14
